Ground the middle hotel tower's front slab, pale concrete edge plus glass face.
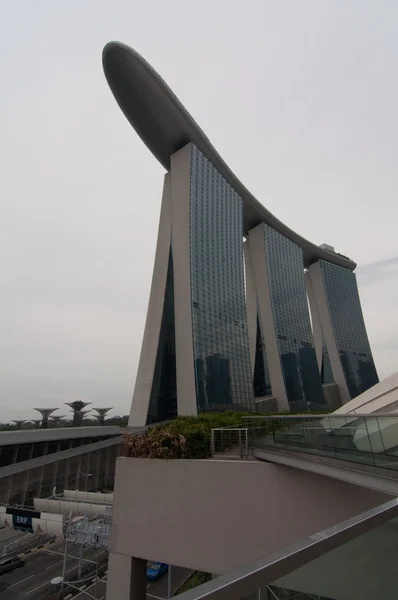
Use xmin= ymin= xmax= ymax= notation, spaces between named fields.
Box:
xmin=249 ymin=223 xmax=325 ymax=411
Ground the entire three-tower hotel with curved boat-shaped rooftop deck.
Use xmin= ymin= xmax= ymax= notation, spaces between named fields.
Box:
xmin=103 ymin=42 xmax=378 ymax=425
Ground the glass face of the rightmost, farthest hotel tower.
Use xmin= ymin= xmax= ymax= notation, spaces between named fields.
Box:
xmin=319 ymin=260 xmax=379 ymax=398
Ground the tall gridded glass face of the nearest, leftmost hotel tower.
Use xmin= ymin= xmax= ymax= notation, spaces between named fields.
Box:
xmin=190 ymin=146 xmax=254 ymax=412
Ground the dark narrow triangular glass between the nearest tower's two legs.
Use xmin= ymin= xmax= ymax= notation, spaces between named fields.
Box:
xmin=147 ymin=248 xmax=177 ymax=424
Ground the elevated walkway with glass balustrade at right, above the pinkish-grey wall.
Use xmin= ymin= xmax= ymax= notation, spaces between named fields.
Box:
xmin=242 ymin=414 xmax=398 ymax=496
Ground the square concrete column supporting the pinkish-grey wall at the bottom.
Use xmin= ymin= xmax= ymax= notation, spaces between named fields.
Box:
xmin=106 ymin=552 xmax=147 ymax=600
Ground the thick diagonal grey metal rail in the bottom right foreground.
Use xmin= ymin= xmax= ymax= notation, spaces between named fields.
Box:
xmin=175 ymin=499 xmax=398 ymax=600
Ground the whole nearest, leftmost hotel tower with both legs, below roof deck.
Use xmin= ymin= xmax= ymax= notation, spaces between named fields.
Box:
xmin=129 ymin=144 xmax=254 ymax=426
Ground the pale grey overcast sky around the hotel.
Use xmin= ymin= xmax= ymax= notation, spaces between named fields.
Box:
xmin=0 ymin=0 xmax=398 ymax=421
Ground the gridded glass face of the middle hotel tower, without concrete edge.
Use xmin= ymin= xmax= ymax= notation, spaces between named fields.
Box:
xmin=263 ymin=224 xmax=325 ymax=412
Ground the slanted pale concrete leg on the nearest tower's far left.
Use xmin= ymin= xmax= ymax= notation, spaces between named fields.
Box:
xmin=129 ymin=173 xmax=171 ymax=426
